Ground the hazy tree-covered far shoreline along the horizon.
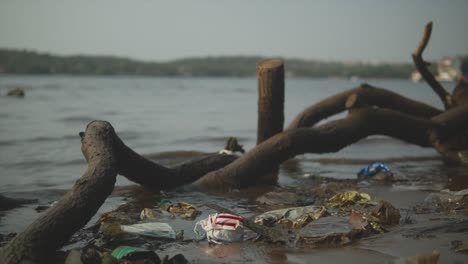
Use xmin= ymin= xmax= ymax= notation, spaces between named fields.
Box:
xmin=0 ymin=49 xmax=414 ymax=79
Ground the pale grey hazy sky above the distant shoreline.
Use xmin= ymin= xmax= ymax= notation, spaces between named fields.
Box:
xmin=0 ymin=0 xmax=468 ymax=63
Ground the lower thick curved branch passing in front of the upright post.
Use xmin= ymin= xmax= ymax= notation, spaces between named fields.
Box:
xmin=194 ymin=107 xmax=437 ymax=190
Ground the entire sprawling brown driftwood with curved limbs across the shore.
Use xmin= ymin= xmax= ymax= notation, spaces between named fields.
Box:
xmin=0 ymin=21 xmax=468 ymax=263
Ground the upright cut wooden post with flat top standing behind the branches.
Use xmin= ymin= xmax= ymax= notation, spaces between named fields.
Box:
xmin=257 ymin=59 xmax=284 ymax=145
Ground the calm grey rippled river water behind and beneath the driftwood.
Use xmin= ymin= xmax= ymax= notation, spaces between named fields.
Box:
xmin=0 ymin=76 xmax=466 ymax=262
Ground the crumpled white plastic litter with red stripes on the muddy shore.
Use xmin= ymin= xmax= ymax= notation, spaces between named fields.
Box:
xmin=193 ymin=213 xmax=244 ymax=244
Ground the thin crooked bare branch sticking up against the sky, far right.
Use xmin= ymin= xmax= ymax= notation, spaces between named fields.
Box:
xmin=412 ymin=22 xmax=452 ymax=109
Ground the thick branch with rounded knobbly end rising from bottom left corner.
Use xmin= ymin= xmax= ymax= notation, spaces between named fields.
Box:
xmin=0 ymin=122 xmax=117 ymax=263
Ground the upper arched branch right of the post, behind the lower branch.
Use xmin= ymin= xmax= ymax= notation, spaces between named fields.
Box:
xmin=288 ymin=84 xmax=442 ymax=130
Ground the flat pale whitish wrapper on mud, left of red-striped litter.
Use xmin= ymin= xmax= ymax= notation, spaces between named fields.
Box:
xmin=120 ymin=222 xmax=176 ymax=239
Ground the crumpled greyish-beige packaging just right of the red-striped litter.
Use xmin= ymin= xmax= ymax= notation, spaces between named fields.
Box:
xmin=254 ymin=205 xmax=328 ymax=228
